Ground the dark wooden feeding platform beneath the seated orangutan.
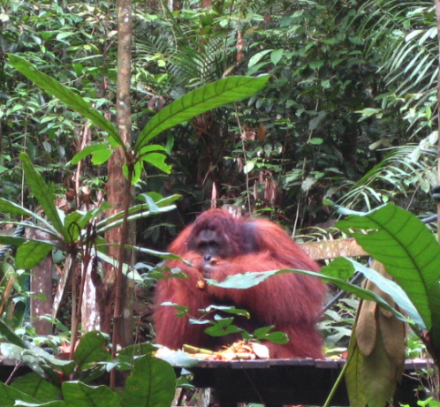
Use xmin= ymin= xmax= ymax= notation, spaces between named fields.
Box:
xmin=174 ymin=359 xmax=432 ymax=406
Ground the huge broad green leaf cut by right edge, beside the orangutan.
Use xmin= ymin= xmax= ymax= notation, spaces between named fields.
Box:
xmin=337 ymin=204 xmax=440 ymax=337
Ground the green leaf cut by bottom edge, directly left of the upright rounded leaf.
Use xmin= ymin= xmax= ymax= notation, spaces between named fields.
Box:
xmin=62 ymin=382 xmax=121 ymax=407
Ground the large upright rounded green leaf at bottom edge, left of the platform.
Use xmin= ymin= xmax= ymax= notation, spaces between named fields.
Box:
xmin=122 ymin=355 xmax=176 ymax=407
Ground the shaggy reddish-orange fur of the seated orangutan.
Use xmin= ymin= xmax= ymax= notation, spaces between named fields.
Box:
xmin=154 ymin=209 xmax=326 ymax=358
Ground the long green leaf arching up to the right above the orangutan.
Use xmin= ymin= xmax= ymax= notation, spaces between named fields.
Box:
xmin=134 ymin=76 xmax=269 ymax=151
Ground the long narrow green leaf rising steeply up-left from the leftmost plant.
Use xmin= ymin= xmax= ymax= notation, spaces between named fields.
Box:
xmin=19 ymin=153 xmax=68 ymax=241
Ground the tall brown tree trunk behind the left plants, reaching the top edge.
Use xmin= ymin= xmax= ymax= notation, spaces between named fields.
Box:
xmin=97 ymin=0 xmax=134 ymax=346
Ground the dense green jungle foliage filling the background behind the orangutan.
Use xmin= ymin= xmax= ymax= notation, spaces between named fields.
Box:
xmin=0 ymin=0 xmax=440 ymax=405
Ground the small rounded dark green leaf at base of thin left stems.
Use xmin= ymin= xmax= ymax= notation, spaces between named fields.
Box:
xmin=75 ymin=331 xmax=111 ymax=369
